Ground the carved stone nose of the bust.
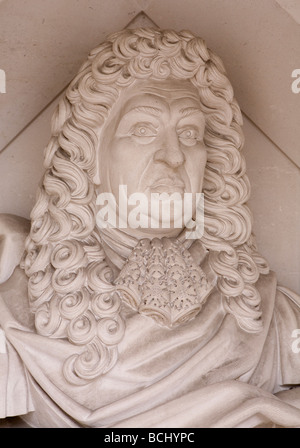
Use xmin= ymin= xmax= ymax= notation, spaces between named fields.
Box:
xmin=154 ymin=129 xmax=185 ymax=168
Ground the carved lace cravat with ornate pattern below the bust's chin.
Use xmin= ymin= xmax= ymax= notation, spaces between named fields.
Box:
xmin=115 ymin=238 xmax=212 ymax=328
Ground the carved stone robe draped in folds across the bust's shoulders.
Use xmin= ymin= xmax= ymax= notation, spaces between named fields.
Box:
xmin=0 ymin=216 xmax=300 ymax=428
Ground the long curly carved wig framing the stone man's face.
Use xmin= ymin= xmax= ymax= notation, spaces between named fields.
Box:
xmin=23 ymin=28 xmax=268 ymax=384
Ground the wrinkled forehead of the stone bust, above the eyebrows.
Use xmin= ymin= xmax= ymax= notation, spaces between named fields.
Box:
xmin=117 ymin=79 xmax=200 ymax=113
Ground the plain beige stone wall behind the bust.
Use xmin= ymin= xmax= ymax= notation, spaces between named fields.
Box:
xmin=0 ymin=4 xmax=300 ymax=292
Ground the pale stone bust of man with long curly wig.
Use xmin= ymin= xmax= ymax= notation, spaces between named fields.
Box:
xmin=0 ymin=28 xmax=300 ymax=427
